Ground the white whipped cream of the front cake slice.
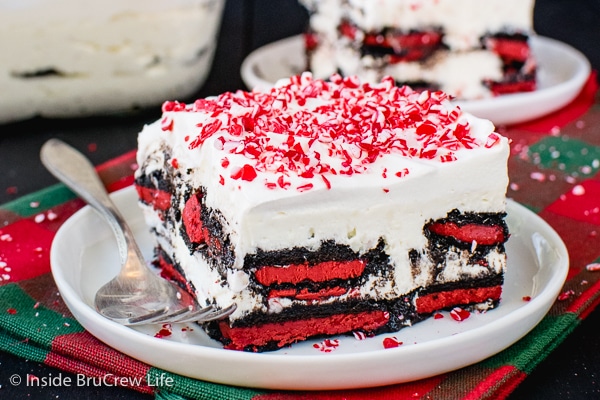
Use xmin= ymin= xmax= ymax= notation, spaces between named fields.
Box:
xmin=137 ymin=74 xmax=509 ymax=318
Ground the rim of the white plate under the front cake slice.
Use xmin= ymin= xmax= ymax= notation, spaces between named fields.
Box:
xmin=50 ymin=186 xmax=569 ymax=390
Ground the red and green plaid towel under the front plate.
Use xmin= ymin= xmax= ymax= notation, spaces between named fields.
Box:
xmin=0 ymin=76 xmax=600 ymax=400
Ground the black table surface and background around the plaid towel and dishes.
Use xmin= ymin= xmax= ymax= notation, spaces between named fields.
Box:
xmin=0 ymin=0 xmax=600 ymax=400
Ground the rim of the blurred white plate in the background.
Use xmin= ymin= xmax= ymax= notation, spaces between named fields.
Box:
xmin=240 ymin=34 xmax=592 ymax=125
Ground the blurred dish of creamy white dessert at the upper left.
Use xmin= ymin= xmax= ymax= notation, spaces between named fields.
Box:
xmin=0 ymin=0 xmax=225 ymax=122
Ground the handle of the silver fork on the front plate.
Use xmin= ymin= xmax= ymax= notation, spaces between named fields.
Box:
xmin=40 ymin=139 xmax=143 ymax=265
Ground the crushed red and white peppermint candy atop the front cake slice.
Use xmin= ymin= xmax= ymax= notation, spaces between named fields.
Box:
xmin=161 ymin=73 xmax=500 ymax=191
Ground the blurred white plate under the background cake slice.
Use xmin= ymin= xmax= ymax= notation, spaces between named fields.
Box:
xmin=241 ymin=36 xmax=591 ymax=125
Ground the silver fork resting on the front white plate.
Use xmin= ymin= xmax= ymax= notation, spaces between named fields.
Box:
xmin=40 ymin=139 xmax=235 ymax=325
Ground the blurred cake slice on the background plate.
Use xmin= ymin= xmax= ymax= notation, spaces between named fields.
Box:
xmin=300 ymin=0 xmax=536 ymax=100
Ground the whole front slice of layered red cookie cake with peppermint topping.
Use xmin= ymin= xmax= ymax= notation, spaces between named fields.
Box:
xmin=135 ymin=73 xmax=509 ymax=351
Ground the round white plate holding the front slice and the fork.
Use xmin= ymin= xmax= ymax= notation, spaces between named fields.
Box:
xmin=51 ymin=188 xmax=568 ymax=390
